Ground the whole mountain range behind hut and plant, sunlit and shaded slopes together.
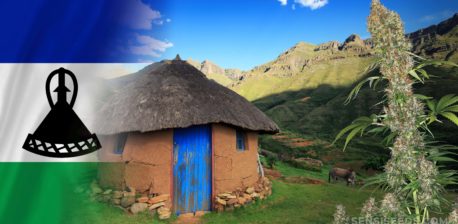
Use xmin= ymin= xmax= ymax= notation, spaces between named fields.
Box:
xmin=230 ymin=14 xmax=458 ymax=143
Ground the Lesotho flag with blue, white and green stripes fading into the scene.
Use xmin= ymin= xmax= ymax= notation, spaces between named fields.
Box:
xmin=0 ymin=0 xmax=172 ymax=223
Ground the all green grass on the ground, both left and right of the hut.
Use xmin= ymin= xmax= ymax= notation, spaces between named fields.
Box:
xmin=68 ymin=163 xmax=381 ymax=224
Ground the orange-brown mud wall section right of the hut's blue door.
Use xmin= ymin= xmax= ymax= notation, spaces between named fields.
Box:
xmin=212 ymin=124 xmax=259 ymax=195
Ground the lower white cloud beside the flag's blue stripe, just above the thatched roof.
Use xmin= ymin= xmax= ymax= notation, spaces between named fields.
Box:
xmin=129 ymin=35 xmax=173 ymax=58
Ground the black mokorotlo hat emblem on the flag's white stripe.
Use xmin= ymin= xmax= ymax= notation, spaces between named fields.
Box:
xmin=22 ymin=68 xmax=101 ymax=158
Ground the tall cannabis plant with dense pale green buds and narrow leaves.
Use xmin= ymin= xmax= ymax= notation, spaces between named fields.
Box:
xmin=336 ymin=0 xmax=458 ymax=223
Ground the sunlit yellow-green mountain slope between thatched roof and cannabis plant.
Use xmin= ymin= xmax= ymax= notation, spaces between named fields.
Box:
xmin=231 ymin=34 xmax=374 ymax=100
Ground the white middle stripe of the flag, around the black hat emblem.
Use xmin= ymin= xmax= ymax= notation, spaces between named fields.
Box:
xmin=0 ymin=63 xmax=136 ymax=162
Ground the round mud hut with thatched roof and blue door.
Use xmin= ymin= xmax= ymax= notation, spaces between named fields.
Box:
xmin=96 ymin=56 xmax=279 ymax=214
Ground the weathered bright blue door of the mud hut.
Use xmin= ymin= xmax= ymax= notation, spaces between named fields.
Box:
xmin=173 ymin=125 xmax=212 ymax=215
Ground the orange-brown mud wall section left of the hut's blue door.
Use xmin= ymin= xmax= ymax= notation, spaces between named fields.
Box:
xmin=99 ymin=130 xmax=173 ymax=197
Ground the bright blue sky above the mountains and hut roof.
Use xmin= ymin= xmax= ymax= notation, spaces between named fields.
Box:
xmin=150 ymin=0 xmax=458 ymax=69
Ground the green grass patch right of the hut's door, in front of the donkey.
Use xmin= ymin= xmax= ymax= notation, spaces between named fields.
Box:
xmin=203 ymin=181 xmax=380 ymax=223
